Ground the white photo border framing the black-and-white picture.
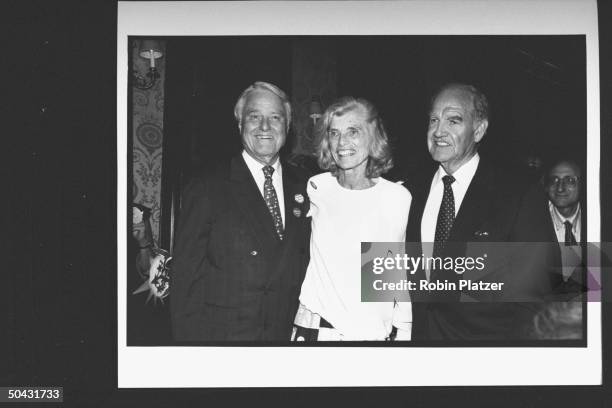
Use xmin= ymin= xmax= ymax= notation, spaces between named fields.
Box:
xmin=117 ymin=0 xmax=602 ymax=388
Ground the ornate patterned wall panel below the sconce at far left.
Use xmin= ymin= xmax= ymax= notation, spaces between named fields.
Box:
xmin=131 ymin=40 xmax=166 ymax=242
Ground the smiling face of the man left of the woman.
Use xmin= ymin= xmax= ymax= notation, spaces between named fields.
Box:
xmin=239 ymin=89 xmax=287 ymax=164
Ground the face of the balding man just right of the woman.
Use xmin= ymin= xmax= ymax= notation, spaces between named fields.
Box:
xmin=427 ymin=88 xmax=488 ymax=174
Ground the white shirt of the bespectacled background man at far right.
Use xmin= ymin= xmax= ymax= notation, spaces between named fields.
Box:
xmin=548 ymin=201 xmax=582 ymax=281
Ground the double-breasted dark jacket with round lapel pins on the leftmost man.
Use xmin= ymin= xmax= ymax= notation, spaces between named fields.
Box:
xmin=170 ymin=156 xmax=310 ymax=341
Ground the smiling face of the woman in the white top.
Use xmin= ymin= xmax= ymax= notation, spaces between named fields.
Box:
xmin=327 ymin=108 xmax=371 ymax=175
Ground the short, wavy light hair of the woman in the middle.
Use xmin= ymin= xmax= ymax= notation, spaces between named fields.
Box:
xmin=315 ymin=96 xmax=393 ymax=178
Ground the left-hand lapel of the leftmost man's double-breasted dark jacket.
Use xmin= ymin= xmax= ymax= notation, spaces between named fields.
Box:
xmin=230 ymin=156 xmax=278 ymax=244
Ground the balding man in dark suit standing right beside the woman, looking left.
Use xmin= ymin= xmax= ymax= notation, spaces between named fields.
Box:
xmin=406 ymin=84 xmax=552 ymax=340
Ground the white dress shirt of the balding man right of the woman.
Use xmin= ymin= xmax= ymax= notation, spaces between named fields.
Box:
xmin=421 ymin=153 xmax=480 ymax=280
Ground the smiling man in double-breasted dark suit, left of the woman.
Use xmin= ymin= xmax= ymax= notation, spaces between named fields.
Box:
xmin=171 ymin=82 xmax=310 ymax=342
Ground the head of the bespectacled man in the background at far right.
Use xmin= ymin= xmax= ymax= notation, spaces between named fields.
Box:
xmin=546 ymin=162 xmax=580 ymax=211
